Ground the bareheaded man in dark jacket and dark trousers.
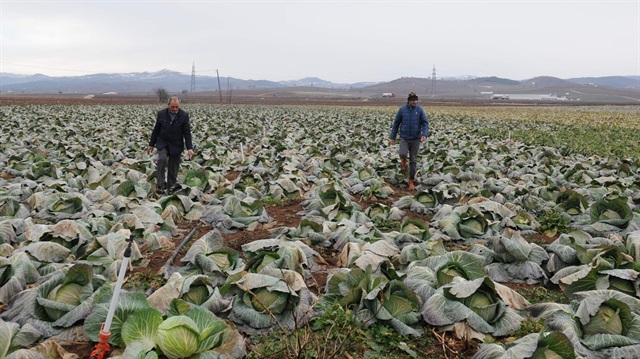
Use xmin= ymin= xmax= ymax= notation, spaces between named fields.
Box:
xmin=147 ymin=96 xmax=193 ymax=194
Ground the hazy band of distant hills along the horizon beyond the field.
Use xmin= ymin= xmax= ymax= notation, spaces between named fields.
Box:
xmin=0 ymin=70 xmax=640 ymax=103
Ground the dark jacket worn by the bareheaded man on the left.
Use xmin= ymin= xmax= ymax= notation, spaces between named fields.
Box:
xmin=149 ymin=108 xmax=193 ymax=156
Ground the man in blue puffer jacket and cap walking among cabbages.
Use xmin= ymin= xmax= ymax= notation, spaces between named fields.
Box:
xmin=389 ymin=92 xmax=429 ymax=190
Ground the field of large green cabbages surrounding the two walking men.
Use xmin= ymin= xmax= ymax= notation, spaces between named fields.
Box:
xmin=0 ymin=103 xmax=640 ymax=359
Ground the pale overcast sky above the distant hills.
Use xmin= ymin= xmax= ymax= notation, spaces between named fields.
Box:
xmin=0 ymin=0 xmax=640 ymax=83
